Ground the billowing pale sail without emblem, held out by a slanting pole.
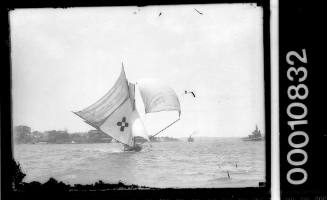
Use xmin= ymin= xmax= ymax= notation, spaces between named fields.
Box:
xmin=138 ymin=79 xmax=181 ymax=115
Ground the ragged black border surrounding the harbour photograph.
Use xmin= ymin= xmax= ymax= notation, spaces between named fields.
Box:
xmin=1 ymin=0 xmax=271 ymax=199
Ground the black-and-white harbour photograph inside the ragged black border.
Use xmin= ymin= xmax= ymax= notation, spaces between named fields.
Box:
xmin=9 ymin=3 xmax=269 ymax=189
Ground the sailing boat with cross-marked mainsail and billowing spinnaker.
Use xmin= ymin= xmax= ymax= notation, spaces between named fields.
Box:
xmin=74 ymin=65 xmax=181 ymax=151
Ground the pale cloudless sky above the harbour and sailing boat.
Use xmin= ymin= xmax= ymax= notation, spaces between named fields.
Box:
xmin=10 ymin=4 xmax=265 ymax=137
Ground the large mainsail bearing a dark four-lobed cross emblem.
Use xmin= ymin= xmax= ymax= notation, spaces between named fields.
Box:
xmin=75 ymin=68 xmax=134 ymax=146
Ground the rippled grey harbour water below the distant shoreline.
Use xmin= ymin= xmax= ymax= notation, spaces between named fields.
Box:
xmin=14 ymin=138 xmax=265 ymax=188
